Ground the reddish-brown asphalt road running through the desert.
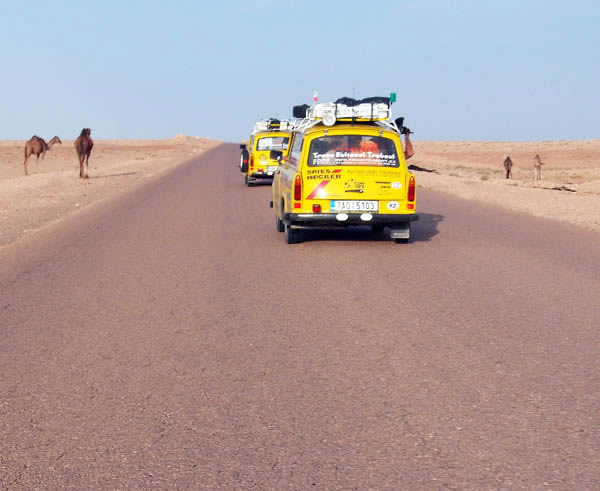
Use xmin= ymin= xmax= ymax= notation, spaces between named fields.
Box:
xmin=0 ymin=145 xmax=600 ymax=490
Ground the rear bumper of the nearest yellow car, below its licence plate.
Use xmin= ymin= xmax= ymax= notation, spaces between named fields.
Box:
xmin=284 ymin=213 xmax=419 ymax=228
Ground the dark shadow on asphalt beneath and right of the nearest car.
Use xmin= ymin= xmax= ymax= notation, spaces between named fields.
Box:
xmin=302 ymin=213 xmax=444 ymax=246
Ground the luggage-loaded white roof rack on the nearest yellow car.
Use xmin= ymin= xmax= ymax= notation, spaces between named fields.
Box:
xmin=294 ymin=97 xmax=400 ymax=132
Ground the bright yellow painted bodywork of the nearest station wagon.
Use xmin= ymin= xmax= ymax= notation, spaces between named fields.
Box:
xmin=273 ymin=124 xmax=416 ymax=220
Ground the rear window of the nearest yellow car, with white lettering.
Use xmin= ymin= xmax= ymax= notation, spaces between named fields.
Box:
xmin=308 ymin=135 xmax=400 ymax=167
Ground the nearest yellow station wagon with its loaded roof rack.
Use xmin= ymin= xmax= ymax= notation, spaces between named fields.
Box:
xmin=271 ymin=97 xmax=419 ymax=244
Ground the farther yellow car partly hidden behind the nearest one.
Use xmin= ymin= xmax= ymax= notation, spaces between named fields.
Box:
xmin=240 ymin=119 xmax=292 ymax=186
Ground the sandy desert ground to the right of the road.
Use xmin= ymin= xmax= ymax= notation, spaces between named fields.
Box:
xmin=408 ymin=140 xmax=600 ymax=232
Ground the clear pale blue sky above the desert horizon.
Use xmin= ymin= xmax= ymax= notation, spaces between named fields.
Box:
xmin=0 ymin=0 xmax=600 ymax=141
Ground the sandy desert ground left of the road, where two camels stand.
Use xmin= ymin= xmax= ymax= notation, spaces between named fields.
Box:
xmin=0 ymin=134 xmax=221 ymax=247
